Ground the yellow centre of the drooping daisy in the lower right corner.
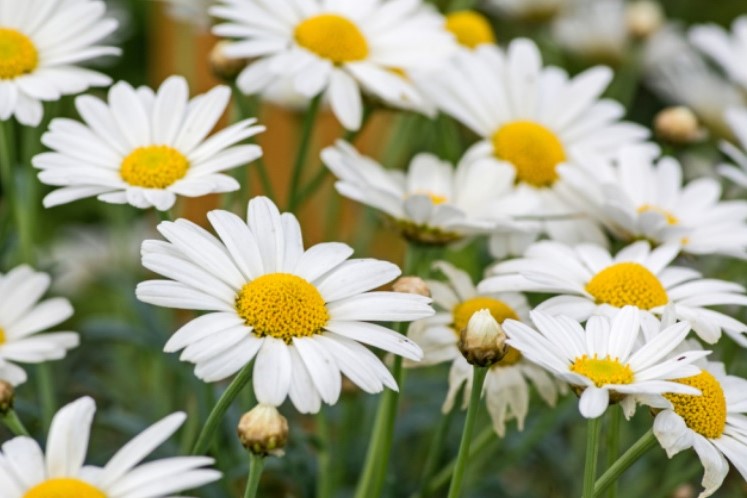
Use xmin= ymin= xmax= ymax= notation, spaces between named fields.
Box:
xmin=664 ymin=371 xmax=726 ymax=439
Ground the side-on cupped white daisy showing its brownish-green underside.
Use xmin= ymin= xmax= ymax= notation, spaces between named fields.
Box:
xmin=322 ymin=141 xmax=515 ymax=244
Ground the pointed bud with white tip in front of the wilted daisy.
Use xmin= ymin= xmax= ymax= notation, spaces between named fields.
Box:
xmin=459 ymin=309 xmax=506 ymax=367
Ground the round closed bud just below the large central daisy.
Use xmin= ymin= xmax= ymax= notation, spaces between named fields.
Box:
xmin=237 ymin=404 xmax=288 ymax=456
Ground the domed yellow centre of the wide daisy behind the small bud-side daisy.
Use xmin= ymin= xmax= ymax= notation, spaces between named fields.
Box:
xmin=586 ymin=262 xmax=669 ymax=310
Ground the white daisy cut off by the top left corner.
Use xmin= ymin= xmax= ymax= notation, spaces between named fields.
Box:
xmin=0 ymin=0 xmax=120 ymax=126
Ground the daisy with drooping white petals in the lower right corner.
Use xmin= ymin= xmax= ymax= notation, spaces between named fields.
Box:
xmin=654 ymin=362 xmax=747 ymax=498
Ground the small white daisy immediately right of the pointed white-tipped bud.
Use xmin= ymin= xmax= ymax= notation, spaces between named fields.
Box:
xmin=503 ymin=306 xmax=708 ymax=418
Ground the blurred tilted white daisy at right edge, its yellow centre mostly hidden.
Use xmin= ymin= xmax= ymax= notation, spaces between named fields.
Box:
xmin=563 ymin=143 xmax=747 ymax=257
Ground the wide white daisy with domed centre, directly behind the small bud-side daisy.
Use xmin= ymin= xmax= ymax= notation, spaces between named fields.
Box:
xmin=478 ymin=241 xmax=747 ymax=347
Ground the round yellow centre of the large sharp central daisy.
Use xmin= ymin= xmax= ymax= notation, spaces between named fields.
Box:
xmin=236 ymin=273 xmax=329 ymax=342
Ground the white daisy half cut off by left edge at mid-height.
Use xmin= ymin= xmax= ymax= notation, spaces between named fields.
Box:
xmin=0 ymin=265 xmax=79 ymax=385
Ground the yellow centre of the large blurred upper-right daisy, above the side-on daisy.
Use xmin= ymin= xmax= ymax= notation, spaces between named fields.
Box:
xmin=492 ymin=121 xmax=565 ymax=187
